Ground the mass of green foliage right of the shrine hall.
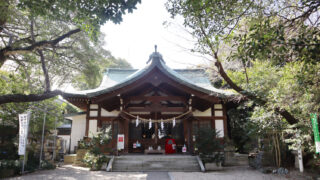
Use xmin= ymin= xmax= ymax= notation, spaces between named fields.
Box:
xmin=167 ymin=0 xmax=320 ymax=167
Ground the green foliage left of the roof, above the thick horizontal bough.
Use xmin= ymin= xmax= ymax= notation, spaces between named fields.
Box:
xmin=0 ymin=0 xmax=134 ymax=101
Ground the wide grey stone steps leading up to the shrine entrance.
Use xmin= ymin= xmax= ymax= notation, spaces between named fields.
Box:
xmin=112 ymin=155 xmax=200 ymax=172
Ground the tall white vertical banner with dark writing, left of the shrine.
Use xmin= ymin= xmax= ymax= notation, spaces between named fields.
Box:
xmin=18 ymin=114 xmax=30 ymax=155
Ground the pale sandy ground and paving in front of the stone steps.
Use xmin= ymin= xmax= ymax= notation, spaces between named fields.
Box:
xmin=5 ymin=165 xmax=312 ymax=180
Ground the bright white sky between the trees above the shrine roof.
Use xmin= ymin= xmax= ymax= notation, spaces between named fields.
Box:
xmin=101 ymin=0 xmax=209 ymax=69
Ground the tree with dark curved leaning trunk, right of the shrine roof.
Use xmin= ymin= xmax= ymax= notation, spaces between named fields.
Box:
xmin=167 ymin=0 xmax=320 ymax=124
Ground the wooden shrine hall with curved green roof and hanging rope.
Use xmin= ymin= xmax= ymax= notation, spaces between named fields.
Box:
xmin=64 ymin=48 xmax=232 ymax=153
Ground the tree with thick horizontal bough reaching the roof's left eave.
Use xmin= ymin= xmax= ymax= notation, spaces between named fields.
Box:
xmin=0 ymin=0 xmax=140 ymax=104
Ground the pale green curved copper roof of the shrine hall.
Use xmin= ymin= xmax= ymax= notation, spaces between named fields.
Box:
xmin=63 ymin=52 xmax=233 ymax=98
